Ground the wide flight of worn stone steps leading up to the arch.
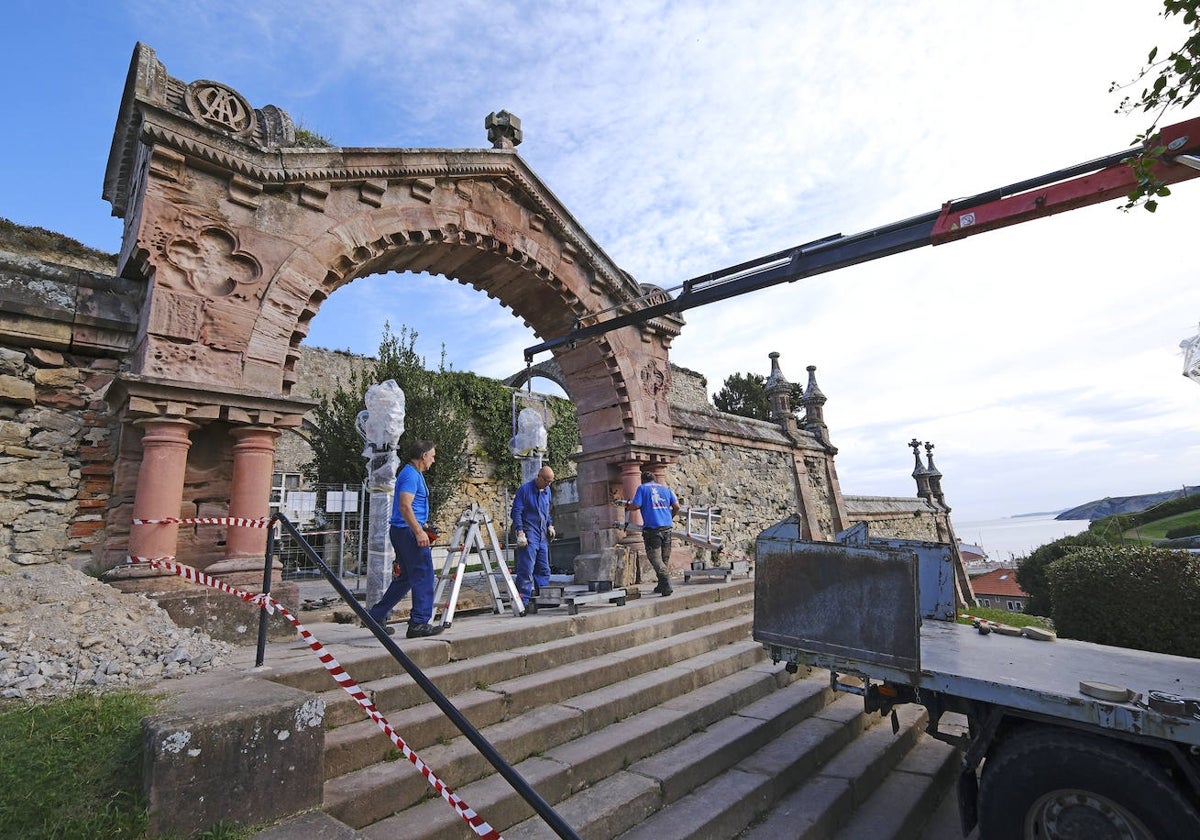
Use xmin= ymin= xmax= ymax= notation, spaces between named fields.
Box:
xmin=250 ymin=581 xmax=961 ymax=840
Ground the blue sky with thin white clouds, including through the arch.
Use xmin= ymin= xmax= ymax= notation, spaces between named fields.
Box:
xmin=0 ymin=0 xmax=1200 ymax=521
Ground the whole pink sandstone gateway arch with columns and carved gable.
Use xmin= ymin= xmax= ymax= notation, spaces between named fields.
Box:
xmin=104 ymin=44 xmax=683 ymax=592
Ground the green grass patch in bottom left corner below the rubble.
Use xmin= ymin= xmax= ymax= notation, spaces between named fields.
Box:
xmin=0 ymin=691 xmax=156 ymax=840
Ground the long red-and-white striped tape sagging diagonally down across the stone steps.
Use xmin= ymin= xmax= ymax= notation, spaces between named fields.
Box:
xmin=126 ymin=557 xmax=503 ymax=840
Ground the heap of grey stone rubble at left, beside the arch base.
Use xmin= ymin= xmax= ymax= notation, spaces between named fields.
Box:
xmin=0 ymin=560 xmax=233 ymax=700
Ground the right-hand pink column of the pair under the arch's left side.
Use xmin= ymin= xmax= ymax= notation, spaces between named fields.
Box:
xmin=224 ymin=426 xmax=280 ymax=565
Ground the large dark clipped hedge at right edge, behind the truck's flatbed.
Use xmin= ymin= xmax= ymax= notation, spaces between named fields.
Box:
xmin=1045 ymin=546 xmax=1200 ymax=658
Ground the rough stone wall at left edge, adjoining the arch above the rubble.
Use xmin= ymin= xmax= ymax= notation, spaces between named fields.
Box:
xmin=0 ymin=242 xmax=132 ymax=569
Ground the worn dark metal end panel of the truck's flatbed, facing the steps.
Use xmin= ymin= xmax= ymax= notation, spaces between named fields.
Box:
xmin=754 ymin=528 xmax=920 ymax=679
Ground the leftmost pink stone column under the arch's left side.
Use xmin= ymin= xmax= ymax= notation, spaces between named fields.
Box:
xmin=130 ymin=418 xmax=199 ymax=558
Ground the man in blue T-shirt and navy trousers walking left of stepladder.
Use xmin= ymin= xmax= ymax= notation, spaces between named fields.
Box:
xmin=367 ymin=440 xmax=445 ymax=638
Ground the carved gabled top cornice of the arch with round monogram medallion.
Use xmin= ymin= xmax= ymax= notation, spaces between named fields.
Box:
xmin=103 ymin=43 xmax=684 ymax=337
